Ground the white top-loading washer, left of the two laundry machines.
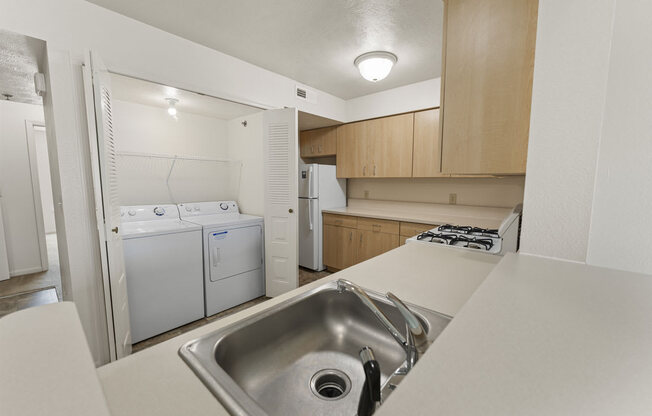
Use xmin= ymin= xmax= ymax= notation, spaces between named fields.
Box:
xmin=120 ymin=205 xmax=204 ymax=343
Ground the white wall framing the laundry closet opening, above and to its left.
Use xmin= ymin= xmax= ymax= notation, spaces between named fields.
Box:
xmin=0 ymin=0 xmax=346 ymax=365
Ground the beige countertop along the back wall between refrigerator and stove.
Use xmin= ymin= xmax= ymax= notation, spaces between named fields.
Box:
xmin=322 ymin=199 xmax=512 ymax=228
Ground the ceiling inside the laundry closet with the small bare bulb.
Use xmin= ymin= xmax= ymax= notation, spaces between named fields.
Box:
xmin=111 ymin=74 xmax=262 ymax=120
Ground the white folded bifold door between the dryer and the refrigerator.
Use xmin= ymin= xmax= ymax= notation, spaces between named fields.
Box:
xmin=263 ymin=108 xmax=299 ymax=297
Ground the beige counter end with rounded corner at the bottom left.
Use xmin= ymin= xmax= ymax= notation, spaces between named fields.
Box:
xmin=0 ymin=302 xmax=109 ymax=416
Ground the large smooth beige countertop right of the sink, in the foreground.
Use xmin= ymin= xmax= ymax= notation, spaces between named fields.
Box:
xmin=377 ymin=254 xmax=652 ymax=416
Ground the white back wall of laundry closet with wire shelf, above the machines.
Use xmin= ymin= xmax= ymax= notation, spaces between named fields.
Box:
xmin=113 ymin=100 xmax=240 ymax=205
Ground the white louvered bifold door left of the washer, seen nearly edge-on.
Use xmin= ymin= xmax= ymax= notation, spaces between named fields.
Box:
xmin=84 ymin=51 xmax=131 ymax=360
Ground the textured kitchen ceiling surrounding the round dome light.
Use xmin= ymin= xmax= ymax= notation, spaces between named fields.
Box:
xmin=88 ymin=0 xmax=443 ymax=99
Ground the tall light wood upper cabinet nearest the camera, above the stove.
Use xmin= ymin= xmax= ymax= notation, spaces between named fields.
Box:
xmin=441 ymin=0 xmax=538 ymax=174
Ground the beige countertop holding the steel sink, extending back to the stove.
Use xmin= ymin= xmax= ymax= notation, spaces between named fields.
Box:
xmin=98 ymin=244 xmax=500 ymax=416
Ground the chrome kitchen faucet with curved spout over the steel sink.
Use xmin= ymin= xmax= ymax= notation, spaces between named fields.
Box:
xmin=337 ymin=279 xmax=428 ymax=375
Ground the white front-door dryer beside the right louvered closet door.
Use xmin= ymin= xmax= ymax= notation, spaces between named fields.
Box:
xmin=179 ymin=201 xmax=265 ymax=316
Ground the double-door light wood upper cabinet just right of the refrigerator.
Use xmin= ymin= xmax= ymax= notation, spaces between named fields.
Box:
xmin=337 ymin=113 xmax=414 ymax=178
